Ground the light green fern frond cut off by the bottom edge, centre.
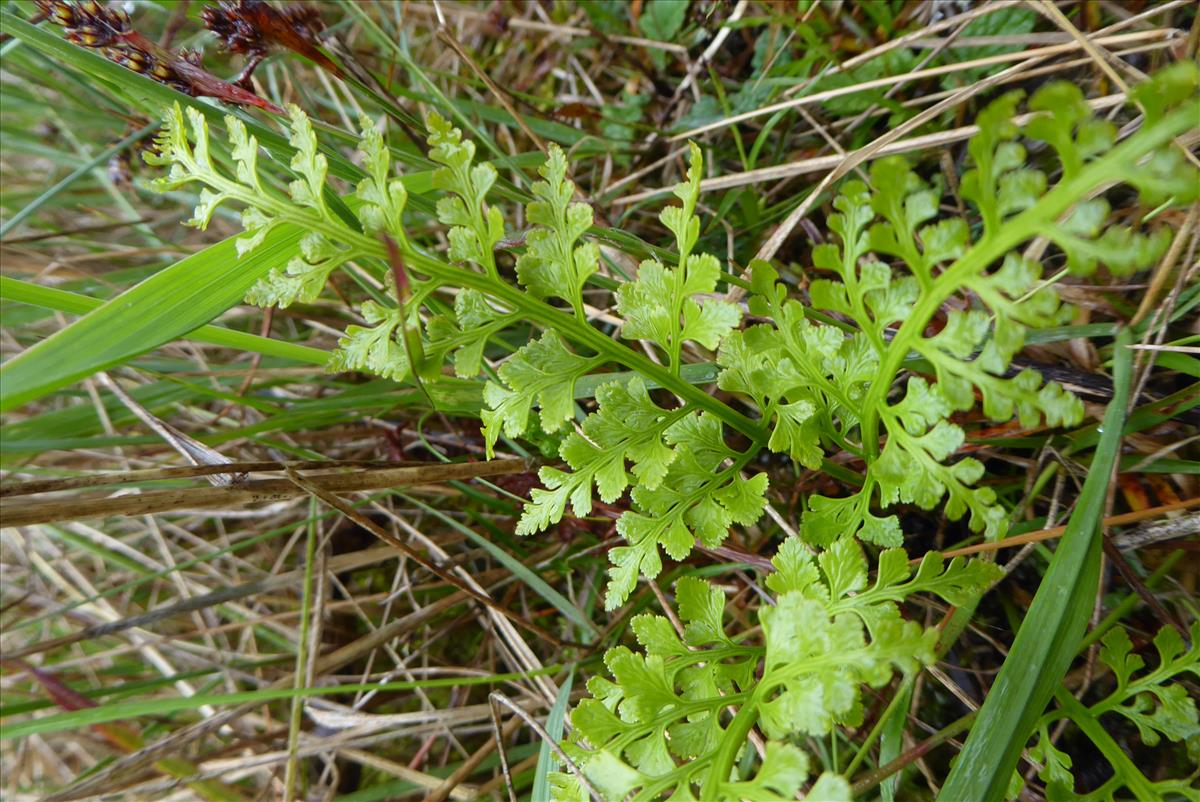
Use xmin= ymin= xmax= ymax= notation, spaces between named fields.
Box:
xmin=549 ymin=538 xmax=1001 ymax=802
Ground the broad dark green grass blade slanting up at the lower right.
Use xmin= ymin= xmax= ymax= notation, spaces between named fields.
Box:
xmin=937 ymin=329 xmax=1133 ymax=802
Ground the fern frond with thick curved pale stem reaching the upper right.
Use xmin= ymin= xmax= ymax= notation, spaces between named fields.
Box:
xmin=721 ymin=73 xmax=1195 ymax=546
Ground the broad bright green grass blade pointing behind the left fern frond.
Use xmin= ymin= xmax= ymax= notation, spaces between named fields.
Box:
xmin=0 ymin=225 xmax=304 ymax=412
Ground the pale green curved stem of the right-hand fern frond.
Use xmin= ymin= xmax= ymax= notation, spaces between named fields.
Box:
xmin=862 ymin=103 xmax=1200 ymax=461
